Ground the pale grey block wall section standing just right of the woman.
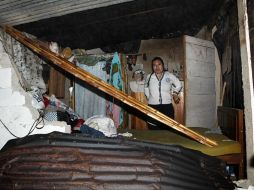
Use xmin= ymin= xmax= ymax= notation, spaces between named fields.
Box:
xmin=184 ymin=36 xmax=216 ymax=128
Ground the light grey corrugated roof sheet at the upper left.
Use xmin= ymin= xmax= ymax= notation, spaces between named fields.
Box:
xmin=0 ymin=0 xmax=133 ymax=25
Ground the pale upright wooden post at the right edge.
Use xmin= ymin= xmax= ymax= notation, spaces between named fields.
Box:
xmin=237 ymin=0 xmax=254 ymax=183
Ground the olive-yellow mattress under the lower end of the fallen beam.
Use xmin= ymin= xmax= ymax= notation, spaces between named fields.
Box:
xmin=118 ymin=127 xmax=241 ymax=156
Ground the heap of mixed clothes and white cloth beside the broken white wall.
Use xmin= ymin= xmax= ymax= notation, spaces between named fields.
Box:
xmin=31 ymin=87 xmax=117 ymax=138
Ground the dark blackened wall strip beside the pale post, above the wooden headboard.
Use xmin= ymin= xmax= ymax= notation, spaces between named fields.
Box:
xmin=213 ymin=2 xmax=243 ymax=109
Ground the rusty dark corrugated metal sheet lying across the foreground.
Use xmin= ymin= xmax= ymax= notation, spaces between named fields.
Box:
xmin=0 ymin=133 xmax=234 ymax=190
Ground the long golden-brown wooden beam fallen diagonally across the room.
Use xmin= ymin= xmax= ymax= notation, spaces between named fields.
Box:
xmin=4 ymin=26 xmax=217 ymax=147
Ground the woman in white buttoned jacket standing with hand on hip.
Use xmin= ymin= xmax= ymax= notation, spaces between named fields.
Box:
xmin=145 ymin=57 xmax=182 ymax=129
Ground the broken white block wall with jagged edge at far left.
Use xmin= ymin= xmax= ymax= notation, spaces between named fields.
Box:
xmin=0 ymin=31 xmax=70 ymax=149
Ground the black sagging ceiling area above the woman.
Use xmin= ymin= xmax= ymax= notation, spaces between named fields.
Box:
xmin=1 ymin=0 xmax=222 ymax=49
